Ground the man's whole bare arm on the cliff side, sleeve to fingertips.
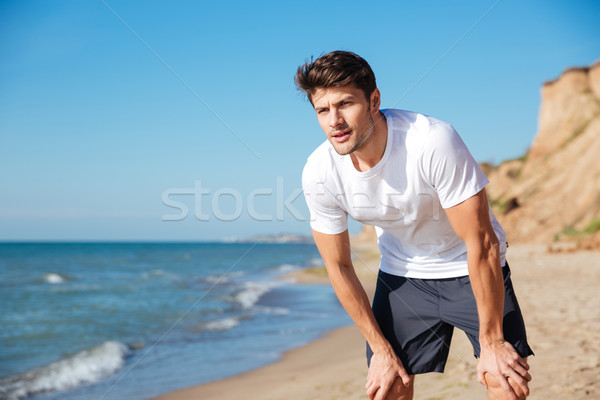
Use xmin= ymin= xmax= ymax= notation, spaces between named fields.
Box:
xmin=445 ymin=189 xmax=531 ymax=398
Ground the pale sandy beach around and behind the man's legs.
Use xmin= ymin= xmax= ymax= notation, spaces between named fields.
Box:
xmin=151 ymin=245 xmax=600 ymax=400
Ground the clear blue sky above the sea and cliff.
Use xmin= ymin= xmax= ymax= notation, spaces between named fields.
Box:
xmin=0 ymin=0 xmax=600 ymax=240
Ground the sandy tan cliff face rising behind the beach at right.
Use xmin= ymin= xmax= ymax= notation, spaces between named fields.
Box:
xmin=488 ymin=62 xmax=600 ymax=247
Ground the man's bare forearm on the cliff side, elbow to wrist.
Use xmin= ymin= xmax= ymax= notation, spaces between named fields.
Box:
xmin=467 ymin=237 xmax=504 ymax=346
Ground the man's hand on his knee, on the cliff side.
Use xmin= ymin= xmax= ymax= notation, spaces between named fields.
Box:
xmin=477 ymin=340 xmax=531 ymax=400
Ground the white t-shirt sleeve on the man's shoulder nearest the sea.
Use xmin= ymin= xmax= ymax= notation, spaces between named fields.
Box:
xmin=302 ymin=161 xmax=348 ymax=235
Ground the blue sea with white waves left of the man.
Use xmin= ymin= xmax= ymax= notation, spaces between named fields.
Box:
xmin=0 ymin=243 xmax=351 ymax=400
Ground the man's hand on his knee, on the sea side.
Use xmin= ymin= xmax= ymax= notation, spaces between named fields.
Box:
xmin=365 ymin=353 xmax=411 ymax=400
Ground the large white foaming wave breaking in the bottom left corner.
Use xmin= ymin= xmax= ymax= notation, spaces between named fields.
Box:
xmin=0 ymin=341 xmax=130 ymax=400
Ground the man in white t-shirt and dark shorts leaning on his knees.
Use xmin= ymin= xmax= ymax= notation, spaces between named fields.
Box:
xmin=295 ymin=51 xmax=533 ymax=400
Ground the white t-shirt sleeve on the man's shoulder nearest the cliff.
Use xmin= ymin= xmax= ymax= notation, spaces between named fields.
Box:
xmin=421 ymin=122 xmax=489 ymax=208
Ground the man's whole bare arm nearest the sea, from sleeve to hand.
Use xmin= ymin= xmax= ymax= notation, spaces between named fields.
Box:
xmin=312 ymin=229 xmax=410 ymax=400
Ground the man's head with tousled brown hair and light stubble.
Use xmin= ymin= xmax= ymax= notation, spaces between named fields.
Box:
xmin=295 ymin=51 xmax=385 ymax=155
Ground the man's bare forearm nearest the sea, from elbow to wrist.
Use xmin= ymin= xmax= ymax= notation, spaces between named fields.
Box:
xmin=327 ymin=264 xmax=393 ymax=353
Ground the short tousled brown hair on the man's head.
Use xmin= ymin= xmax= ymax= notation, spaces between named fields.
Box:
xmin=294 ymin=50 xmax=377 ymax=104
